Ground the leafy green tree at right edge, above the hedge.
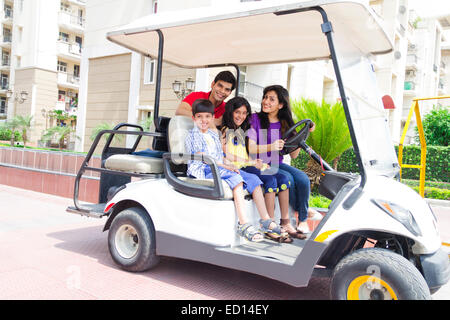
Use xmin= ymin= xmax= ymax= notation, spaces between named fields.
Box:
xmin=415 ymin=106 xmax=450 ymax=147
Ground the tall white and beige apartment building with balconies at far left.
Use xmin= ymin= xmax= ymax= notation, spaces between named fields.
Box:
xmin=0 ymin=0 xmax=86 ymax=143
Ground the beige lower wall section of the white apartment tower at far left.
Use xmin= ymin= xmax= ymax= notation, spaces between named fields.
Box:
xmin=14 ymin=68 xmax=58 ymax=143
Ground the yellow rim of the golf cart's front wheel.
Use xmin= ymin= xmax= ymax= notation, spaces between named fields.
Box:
xmin=347 ymin=276 xmax=398 ymax=300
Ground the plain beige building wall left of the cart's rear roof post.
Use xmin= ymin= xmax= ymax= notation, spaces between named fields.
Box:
xmin=84 ymin=54 xmax=131 ymax=151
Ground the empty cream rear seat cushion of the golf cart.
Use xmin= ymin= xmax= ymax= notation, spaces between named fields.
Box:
xmin=105 ymin=154 xmax=164 ymax=174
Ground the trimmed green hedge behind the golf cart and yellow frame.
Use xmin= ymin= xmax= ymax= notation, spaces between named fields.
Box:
xmin=292 ymin=145 xmax=450 ymax=182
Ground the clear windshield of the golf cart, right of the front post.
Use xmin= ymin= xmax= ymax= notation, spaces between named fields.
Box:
xmin=334 ymin=34 xmax=399 ymax=177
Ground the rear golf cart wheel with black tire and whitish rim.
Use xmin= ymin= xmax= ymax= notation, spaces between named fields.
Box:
xmin=108 ymin=207 xmax=159 ymax=272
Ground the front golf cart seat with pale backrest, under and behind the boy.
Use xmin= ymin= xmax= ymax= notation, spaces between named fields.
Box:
xmin=168 ymin=116 xmax=249 ymax=200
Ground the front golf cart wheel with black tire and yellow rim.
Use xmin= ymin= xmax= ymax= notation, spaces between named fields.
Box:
xmin=330 ymin=248 xmax=431 ymax=300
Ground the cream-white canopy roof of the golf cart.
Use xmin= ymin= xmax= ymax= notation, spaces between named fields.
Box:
xmin=107 ymin=0 xmax=393 ymax=68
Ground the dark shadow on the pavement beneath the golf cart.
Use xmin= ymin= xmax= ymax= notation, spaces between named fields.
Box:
xmin=47 ymin=226 xmax=329 ymax=300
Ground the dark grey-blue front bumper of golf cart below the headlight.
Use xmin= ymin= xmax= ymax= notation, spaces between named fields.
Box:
xmin=420 ymin=247 xmax=450 ymax=289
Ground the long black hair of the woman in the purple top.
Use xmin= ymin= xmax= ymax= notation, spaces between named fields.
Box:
xmin=258 ymin=85 xmax=295 ymax=134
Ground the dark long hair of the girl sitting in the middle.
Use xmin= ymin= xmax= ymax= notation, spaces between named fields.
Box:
xmin=221 ymin=97 xmax=252 ymax=153
